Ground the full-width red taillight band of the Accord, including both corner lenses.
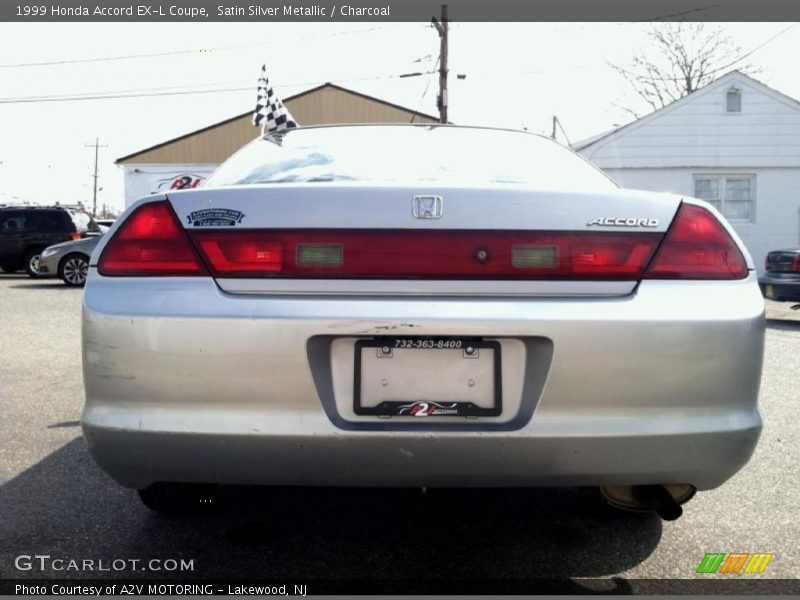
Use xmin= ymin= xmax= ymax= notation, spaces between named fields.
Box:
xmin=98 ymin=201 xmax=752 ymax=280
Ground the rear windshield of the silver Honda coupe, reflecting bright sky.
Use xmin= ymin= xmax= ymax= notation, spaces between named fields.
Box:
xmin=207 ymin=126 xmax=616 ymax=191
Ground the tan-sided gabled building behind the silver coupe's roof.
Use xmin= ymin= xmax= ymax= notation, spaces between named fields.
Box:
xmin=116 ymin=83 xmax=438 ymax=206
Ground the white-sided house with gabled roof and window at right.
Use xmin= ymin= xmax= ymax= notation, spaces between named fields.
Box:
xmin=576 ymin=71 xmax=800 ymax=271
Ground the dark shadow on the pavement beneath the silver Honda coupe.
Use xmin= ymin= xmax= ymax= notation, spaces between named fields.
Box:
xmin=0 ymin=437 xmax=662 ymax=593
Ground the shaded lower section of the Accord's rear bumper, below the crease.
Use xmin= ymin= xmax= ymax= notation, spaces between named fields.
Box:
xmin=84 ymin=414 xmax=761 ymax=489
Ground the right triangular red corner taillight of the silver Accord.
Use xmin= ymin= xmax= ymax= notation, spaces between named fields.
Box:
xmin=644 ymin=204 xmax=747 ymax=279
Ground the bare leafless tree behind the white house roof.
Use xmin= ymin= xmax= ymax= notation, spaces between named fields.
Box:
xmin=609 ymin=22 xmax=757 ymax=118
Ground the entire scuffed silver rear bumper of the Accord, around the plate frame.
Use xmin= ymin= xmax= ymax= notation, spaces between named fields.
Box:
xmin=82 ymin=273 xmax=764 ymax=489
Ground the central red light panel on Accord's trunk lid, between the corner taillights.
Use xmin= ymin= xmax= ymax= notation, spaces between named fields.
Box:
xmin=189 ymin=229 xmax=661 ymax=280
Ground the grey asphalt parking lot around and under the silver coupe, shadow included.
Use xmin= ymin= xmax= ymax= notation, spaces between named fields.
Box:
xmin=0 ymin=274 xmax=800 ymax=591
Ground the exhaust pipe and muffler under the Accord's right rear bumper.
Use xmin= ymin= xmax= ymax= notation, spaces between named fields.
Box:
xmin=600 ymin=483 xmax=697 ymax=521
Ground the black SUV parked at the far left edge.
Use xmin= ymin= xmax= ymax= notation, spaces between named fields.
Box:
xmin=0 ymin=206 xmax=81 ymax=277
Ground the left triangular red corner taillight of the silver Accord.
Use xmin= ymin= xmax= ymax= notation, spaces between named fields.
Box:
xmin=98 ymin=201 xmax=208 ymax=277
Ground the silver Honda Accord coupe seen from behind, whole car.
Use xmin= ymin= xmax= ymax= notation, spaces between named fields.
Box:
xmin=82 ymin=125 xmax=765 ymax=518
